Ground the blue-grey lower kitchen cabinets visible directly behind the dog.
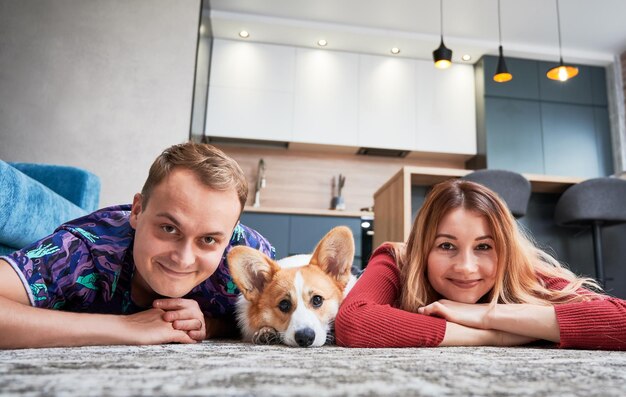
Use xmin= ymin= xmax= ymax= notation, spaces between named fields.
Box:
xmin=241 ymin=212 xmax=362 ymax=269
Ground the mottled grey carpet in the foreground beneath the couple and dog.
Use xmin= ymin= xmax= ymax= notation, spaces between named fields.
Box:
xmin=0 ymin=341 xmax=626 ymax=397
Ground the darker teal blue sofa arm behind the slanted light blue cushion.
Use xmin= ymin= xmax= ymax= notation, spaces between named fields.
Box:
xmin=8 ymin=163 xmax=100 ymax=212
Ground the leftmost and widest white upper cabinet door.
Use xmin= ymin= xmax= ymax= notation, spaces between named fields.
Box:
xmin=205 ymin=39 xmax=295 ymax=141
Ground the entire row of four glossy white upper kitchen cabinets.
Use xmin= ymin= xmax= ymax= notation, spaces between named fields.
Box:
xmin=205 ymin=39 xmax=476 ymax=155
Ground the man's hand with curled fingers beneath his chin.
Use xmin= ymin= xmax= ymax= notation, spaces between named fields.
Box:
xmin=152 ymin=298 xmax=207 ymax=342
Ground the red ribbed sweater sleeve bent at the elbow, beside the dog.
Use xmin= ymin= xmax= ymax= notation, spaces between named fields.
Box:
xmin=335 ymin=245 xmax=446 ymax=347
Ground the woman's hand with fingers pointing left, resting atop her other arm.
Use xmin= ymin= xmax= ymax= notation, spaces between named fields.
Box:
xmin=417 ymin=299 xmax=495 ymax=329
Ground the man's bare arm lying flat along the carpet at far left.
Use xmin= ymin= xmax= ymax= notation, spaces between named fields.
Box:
xmin=0 ymin=259 xmax=195 ymax=349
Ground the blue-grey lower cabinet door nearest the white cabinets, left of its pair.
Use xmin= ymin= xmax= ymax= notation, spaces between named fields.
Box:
xmin=485 ymin=97 xmax=540 ymax=175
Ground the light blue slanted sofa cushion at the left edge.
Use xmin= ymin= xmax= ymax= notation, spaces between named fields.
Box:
xmin=0 ymin=160 xmax=89 ymax=249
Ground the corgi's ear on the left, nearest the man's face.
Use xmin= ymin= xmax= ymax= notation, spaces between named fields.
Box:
xmin=227 ymin=246 xmax=279 ymax=301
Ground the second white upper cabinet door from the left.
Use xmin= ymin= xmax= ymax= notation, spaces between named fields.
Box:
xmin=293 ymin=48 xmax=359 ymax=146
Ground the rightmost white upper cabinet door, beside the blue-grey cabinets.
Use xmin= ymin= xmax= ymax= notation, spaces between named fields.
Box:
xmin=414 ymin=61 xmax=476 ymax=154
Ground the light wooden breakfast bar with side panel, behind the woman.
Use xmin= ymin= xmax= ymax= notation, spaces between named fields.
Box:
xmin=374 ymin=167 xmax=584 ymax=247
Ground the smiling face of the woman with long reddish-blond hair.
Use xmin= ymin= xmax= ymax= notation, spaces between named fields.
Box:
xmin=427 ymin=208 xmax=498 ymax=303
